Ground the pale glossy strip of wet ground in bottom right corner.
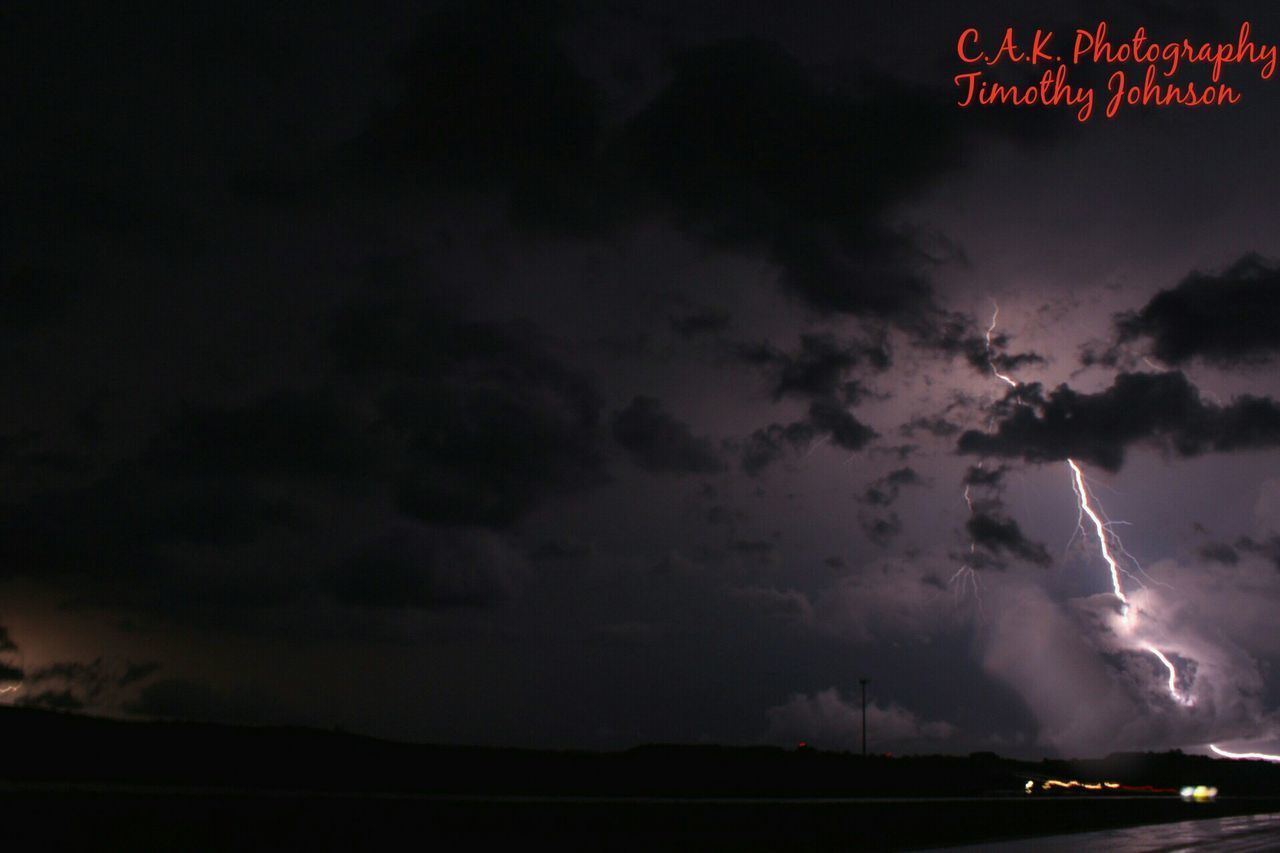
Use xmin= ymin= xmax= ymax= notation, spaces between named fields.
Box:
xmin=922 ymin=813 xmax=1280 ymax=853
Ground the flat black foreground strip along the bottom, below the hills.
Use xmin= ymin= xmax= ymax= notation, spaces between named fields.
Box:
xmin=0 ymin=790 xmax=1280 ymax=850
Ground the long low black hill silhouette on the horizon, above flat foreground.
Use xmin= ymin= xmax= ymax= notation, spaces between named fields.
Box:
xmin=0 ymin=708 xmax=1280 ymax=797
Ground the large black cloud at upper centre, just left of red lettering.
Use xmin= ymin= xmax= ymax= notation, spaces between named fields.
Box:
xmin=627 ymin=38 xmax=956 ymax=316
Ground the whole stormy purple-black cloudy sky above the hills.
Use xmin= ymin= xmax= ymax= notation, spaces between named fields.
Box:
xmin=0 ymin=0 xmax=1280 ymax=756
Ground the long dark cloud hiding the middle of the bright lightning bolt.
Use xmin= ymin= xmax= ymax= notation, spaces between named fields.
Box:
xmin=959 ymin=371 xmax=1280 ymax=471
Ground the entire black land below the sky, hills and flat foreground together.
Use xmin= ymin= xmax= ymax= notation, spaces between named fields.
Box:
xmin=0 ymin=708 xmax=1280 ymax=850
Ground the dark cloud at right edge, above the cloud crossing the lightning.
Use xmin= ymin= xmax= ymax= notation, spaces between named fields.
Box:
xmin=1116 ymin=255 xmax=1280 ymax=366
